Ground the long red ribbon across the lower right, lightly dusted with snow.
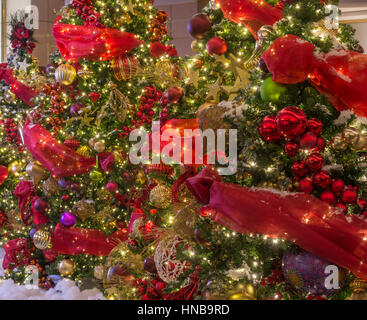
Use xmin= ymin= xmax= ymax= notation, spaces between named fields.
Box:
xmin=186 ymin=167 xmax=367 ymax=280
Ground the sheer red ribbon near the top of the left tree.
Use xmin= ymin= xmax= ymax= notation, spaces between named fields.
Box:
xmin=53 ymin=17 xmax=143 ymax=62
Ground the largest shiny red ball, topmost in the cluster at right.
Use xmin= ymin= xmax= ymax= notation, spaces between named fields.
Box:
xmin=276 ymin=107 xmax=307 ymax=139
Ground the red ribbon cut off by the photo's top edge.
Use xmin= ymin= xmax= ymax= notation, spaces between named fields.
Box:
xmin=216 ymin=0 xmax=283 ymax=40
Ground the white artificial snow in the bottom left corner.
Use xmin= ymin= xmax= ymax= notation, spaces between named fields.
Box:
xmin=0 ymin=249 xmax=106 ymax=300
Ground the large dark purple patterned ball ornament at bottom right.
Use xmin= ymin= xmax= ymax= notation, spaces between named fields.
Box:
xmin=282 ymin=251 xmax=346 ymax=296
